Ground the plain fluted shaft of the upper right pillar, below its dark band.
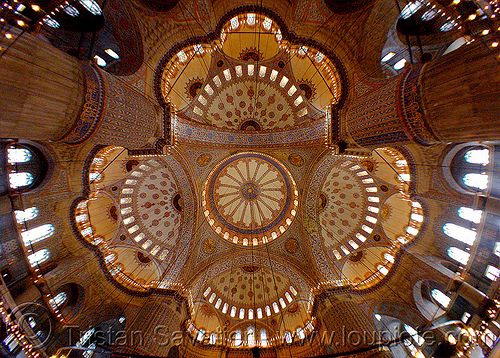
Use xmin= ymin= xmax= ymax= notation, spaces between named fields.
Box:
xmin=420 ymin=39 xmax=500 ymax=142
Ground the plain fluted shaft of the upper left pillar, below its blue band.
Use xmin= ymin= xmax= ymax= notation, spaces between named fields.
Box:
xmin=0 ymin=33 xmax=84 ymax=141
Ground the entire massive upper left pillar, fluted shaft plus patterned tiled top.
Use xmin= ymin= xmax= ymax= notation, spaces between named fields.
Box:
xmin=0 ymin=34 xmax=159 ymax=149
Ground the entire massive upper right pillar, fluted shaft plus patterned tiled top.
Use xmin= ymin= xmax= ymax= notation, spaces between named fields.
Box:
xmin=344 ymin=39 xmax=500 ymax=147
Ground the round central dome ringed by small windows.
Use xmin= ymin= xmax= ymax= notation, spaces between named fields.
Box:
xmin=203 ymin=152 xmax=298 ymax=245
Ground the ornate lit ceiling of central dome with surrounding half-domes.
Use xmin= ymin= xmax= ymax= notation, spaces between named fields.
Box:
xmin=68 ymin=7 xmax=423 ymax=345
